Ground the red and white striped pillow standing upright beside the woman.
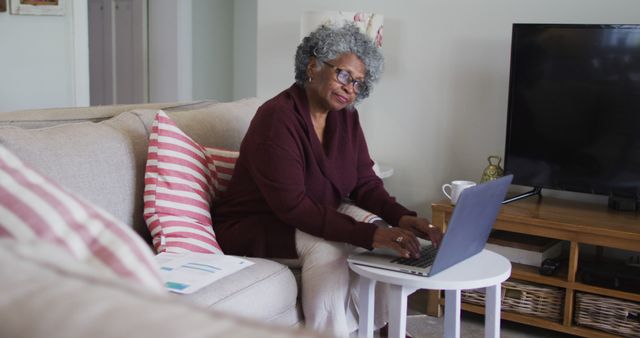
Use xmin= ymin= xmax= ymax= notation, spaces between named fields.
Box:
xmin=143 ymin=111 xmax=238 ymax=253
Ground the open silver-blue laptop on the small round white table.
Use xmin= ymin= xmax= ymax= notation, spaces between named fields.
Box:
xmin=347 ymin=175 xmax=513 ymax=277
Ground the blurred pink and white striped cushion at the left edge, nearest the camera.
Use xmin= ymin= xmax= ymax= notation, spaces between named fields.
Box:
xmin=0 ymin=145 xmax=164 ymax=291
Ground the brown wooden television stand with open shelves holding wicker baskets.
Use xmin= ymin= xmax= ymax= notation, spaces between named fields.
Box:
xmin=426 ymin=197 xmax=640 ymax=338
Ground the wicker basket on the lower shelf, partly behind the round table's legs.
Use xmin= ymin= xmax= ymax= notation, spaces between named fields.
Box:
xmin=462 ymin=280 xmax=564 ymax=322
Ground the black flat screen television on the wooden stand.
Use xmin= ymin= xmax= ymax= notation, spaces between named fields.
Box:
xmin=505 ymin=23 xmax=640 ymax=209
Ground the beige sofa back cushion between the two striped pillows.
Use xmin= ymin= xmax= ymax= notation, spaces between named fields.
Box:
xmin=0 ymin=113 xmax=149 ymax=240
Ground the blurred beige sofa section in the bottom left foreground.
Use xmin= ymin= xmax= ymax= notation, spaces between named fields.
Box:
xmin=0 ymin=239 xmax=320 ymax=338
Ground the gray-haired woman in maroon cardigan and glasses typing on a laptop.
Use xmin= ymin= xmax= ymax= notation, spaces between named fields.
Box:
xmin=213 ymin=25 xmax=441 ymax=337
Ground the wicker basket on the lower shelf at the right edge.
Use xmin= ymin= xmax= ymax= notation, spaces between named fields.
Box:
xmin=575 ymin=292 xmax=640 ymax=337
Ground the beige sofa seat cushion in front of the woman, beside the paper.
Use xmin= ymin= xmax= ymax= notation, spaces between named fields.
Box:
xmin=181 ymin=257 xmax=301 ymax=326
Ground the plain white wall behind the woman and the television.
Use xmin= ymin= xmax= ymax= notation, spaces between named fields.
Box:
xmin=257 ymin=0 xmax=640 ymax=216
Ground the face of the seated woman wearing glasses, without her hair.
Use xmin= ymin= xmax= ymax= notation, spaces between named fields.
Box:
xmin=306 ymin=53 xmax=365 ymax=111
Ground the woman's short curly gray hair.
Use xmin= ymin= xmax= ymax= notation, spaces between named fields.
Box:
xmin=295 ymin=23 xmax=384 ymax=102
